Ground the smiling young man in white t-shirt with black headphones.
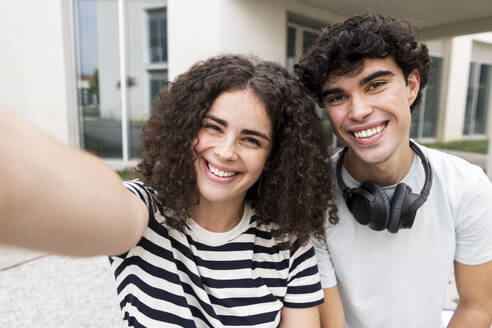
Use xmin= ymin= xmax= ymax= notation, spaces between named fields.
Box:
xmin=295 ymin=14 xmax=492 ymax=328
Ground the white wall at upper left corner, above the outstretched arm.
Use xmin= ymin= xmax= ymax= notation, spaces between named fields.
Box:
xmin=0 ymin=0 xmax=78 ymax=145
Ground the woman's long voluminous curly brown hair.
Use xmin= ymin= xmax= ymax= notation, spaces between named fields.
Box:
xmin=138 ymin=55 xmax=337 ymax=244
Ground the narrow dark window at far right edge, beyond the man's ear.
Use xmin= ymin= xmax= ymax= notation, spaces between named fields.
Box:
xmin=463 ymin=62 xmax=492 ymax=136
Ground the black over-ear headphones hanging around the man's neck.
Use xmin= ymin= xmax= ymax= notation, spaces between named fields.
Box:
xmin=336 ymin=140 xmax=432 ymax=233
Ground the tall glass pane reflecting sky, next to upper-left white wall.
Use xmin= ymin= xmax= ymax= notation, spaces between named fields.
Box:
xmin=75 ymin=0 xmax=122 ymax=158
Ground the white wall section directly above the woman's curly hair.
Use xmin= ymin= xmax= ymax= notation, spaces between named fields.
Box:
xmin=168 ymin=0 xmax=342 ymax=80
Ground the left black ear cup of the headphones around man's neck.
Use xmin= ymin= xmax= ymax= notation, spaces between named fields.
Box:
xmin=347 ymin=181 xmax=390 ymax=231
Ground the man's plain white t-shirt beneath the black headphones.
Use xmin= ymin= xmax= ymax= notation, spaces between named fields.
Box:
xmin=316 ymin=146 xmax=492 ymax=328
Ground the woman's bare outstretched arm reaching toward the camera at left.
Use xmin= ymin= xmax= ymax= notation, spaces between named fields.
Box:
xmin=0 ymin=110 xmax=148 ymax=256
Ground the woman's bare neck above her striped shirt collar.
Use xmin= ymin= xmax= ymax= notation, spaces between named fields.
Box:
xmin=188 ymin=199 xmax=244 ymax=232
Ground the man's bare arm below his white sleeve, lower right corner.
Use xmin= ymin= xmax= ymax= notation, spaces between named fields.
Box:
xmin=448 ymin=261 xmax=492 ymax=328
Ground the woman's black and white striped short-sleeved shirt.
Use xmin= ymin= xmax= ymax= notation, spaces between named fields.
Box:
xmin=110 ymin=181 xmax=323 ymax=328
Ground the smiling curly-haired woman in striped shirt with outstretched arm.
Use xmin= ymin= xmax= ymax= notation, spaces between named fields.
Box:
xmin=0 ymin=55 xmax=336 ymax=327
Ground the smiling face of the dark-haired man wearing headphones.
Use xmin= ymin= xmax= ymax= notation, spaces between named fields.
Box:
xmin=322 ymin=57 xmax=420 ymax=168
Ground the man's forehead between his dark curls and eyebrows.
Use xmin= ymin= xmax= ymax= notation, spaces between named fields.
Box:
xmin=321 ymin=57 xmax=403 ymax=91
